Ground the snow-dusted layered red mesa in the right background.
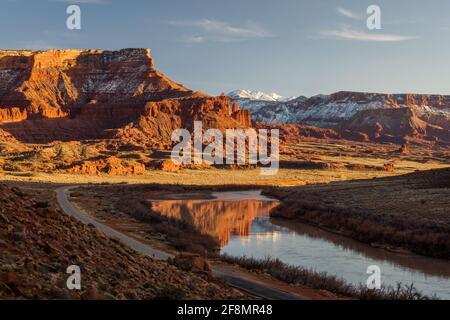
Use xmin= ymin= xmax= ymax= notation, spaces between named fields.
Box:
xmin=236 ymin=91 xmax=450 ymax=144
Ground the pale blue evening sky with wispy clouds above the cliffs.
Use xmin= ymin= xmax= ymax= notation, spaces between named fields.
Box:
xmin=0 ymin=0 xmax=450 ymax=96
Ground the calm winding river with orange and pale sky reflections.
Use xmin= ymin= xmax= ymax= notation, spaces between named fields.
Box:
xmin=152 ymin=191 xmax=450 ymax=299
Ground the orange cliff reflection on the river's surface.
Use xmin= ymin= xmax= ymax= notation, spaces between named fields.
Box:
xmin=151 ymin=193 xmax=278 ymax=247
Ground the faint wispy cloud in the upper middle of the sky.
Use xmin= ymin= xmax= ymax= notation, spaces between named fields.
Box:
xmin=166 ymin=19 xmax=272 ymax=43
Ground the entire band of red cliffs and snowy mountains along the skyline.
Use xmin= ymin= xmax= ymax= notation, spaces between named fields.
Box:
xmin=0 ymin=49 xmax=450 ymax=149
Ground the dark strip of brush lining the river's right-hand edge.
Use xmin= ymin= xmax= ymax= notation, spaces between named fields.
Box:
xmin=271 ymin=200 xmax=450 ymax=259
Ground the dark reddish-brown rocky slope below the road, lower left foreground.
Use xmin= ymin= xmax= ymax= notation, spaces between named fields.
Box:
xmin=0 ymin=185 xmax=246 ymax=299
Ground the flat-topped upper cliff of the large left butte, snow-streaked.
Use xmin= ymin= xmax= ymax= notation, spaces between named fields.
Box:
xmin=0 ymin=49 xmax=192 ymax=118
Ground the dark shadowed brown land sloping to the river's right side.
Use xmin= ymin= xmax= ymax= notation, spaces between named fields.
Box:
xmin=264 ymin=169 xmax=450 ymax=259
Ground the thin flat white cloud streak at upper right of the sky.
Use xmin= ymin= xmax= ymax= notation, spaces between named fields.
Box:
xmin=320 ymin=26 xmax=417 ymax=42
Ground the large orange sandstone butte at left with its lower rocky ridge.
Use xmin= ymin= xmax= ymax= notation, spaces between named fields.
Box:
xmin=0 ymin=49 xmax=252 ymax=145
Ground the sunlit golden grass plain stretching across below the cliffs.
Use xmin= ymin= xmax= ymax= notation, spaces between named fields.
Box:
xmin=0 ymin=139 xmax=450 ymax=186
